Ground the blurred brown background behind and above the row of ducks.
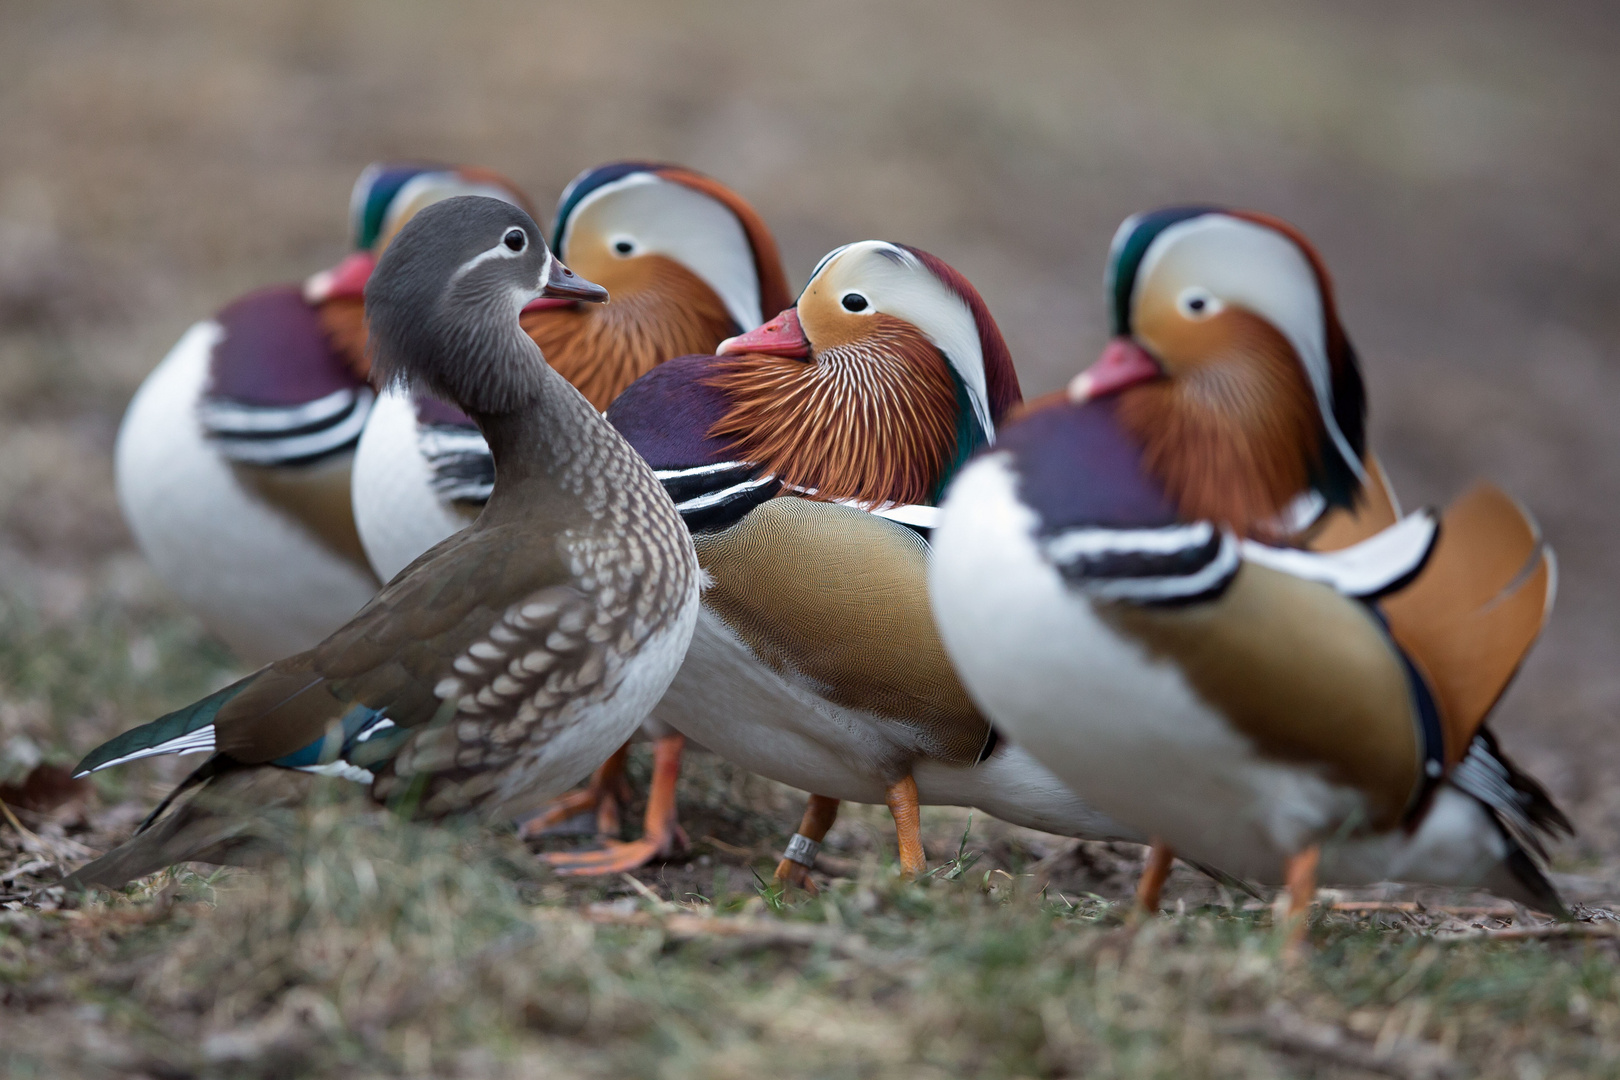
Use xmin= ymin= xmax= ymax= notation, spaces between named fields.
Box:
xmin=9 ymin=0 xmax=1620 ymax=866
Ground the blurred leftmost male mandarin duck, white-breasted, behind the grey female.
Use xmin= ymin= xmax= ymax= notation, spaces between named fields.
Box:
xmin=117 ymin=165 xmax=527 ymax=664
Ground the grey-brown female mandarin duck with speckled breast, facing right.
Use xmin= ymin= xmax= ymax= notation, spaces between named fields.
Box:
xmin=64 ymin=198 xmax=698 ymax=886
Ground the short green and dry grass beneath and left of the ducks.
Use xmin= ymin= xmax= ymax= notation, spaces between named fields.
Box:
xmin=0 ymin=579 xmax=1620 ymax=1080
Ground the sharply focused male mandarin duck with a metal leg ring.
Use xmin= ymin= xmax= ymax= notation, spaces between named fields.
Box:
xmin=596 ymin=241 xmax=1129 ymax=884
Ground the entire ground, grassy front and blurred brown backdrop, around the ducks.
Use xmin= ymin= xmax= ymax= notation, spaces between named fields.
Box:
xmin=0 ymin=0 xmax=1620 ymax=1080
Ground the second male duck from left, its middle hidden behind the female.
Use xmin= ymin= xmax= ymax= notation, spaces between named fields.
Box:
xmin=353 ymin=162 xmax=791 ymax=871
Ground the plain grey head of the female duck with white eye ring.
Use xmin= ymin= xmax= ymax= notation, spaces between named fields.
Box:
xmin=366 ymin=196 xmax=608 ymax=416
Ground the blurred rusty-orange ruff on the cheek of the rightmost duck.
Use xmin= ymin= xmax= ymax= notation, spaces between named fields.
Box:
xmin=1119 ymin=308 xmax=1325 ymax=539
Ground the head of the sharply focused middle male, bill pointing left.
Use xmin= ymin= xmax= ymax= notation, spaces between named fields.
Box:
xmin=710 ymin=240 xmax=1022 ymax=505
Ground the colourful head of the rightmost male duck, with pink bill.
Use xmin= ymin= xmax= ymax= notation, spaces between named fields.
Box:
xmin=1068 ymin=207 xmax=1366 ymax=534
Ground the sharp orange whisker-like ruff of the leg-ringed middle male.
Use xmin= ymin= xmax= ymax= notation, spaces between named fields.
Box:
xmin=706 ymin=314 xmax=977 ymax=505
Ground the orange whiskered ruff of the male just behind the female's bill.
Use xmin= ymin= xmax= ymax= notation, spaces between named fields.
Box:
xmin=522 ymin=254 xmax=737 ymax=410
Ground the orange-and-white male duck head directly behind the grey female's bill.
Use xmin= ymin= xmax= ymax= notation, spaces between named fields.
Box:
xmin=523 ymin=162 xmax=789 ymax=408
